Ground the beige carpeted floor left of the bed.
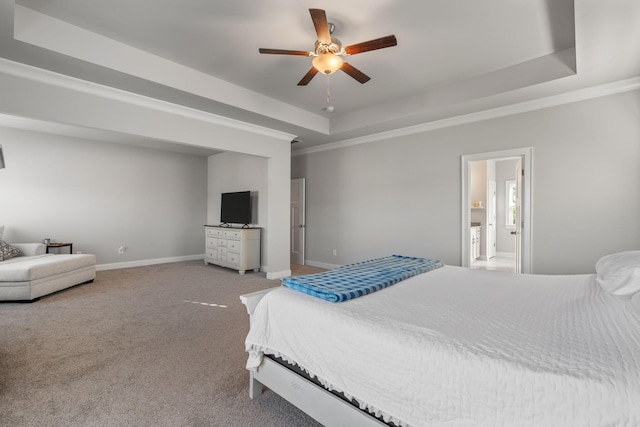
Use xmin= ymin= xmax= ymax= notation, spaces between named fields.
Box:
xmin=0 ymin=261 xmax=319 ymax=426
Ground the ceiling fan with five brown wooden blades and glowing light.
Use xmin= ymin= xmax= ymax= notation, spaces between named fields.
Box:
xmin=259 ymin=9 xmax=398 ymax=86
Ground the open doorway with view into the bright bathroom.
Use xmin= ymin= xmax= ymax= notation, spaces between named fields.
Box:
xmin=461 ymin=147 xmax=533 ymax=273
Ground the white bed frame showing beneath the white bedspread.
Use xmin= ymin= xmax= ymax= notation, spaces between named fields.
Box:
xmin=240 ymin=288 xmax=388 ymax=427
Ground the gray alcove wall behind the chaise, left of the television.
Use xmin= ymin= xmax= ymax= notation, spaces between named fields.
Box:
xmin=0 ymin=127 xmax=207 ymax=265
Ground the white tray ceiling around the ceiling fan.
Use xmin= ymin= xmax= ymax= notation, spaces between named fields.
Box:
xmin=0 ymin=0 xmax=640 ymax=154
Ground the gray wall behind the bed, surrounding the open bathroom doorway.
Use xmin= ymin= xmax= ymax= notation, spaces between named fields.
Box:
xmin=292 ymin=91 xmax=640 ymax=274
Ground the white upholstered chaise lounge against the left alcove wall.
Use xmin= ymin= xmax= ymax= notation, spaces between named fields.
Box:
xmin=0 ymin=243 xmax=96 ymax=301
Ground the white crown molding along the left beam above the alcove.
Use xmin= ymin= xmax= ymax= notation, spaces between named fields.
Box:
xmin=0 ymin=58 xmax=295 ymax=142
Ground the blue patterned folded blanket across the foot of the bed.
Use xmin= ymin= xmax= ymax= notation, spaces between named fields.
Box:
xmin=282 ymin=255 xmax=443 ymax=302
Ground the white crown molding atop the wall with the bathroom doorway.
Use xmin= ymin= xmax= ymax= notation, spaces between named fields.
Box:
xmin=291 ymin=77 xmax=640 ymax=157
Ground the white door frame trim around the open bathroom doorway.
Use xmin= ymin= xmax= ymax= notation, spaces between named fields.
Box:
xmin=460 ymin=147 xmax=533 ymax=274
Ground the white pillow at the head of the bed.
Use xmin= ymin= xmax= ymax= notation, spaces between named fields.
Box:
xmin=596 ymin=251 xmax=640 ymax=296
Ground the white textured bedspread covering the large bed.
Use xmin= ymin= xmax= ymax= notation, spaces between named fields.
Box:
xmin=246 ymin=266 xmax=640 ymax=427
